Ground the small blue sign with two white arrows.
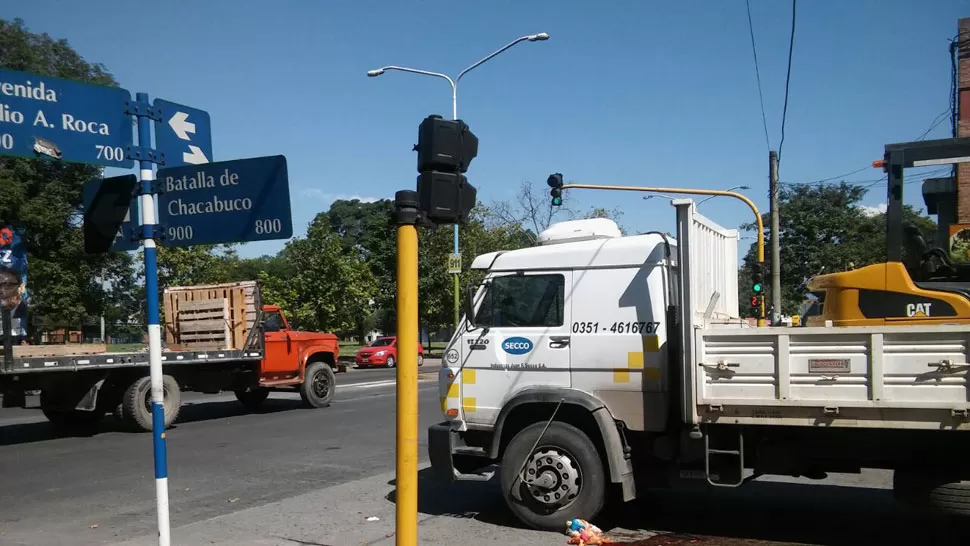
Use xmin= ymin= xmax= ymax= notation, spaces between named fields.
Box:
xmin=152 ymin=99 xmax=212 ymax=167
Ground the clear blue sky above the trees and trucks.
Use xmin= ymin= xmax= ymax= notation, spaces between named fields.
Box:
xmin=9 ymin=0 xmax=970 ymax=255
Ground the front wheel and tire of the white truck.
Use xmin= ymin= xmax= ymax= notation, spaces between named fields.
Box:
xmin=499 ymin=421 xmax=607 ymax=531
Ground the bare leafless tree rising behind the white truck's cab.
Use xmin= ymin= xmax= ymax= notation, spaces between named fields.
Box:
xmin=482 ymin=182 xmax=623 ymax=245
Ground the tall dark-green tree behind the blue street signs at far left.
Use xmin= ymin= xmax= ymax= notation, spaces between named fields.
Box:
xmin=0 ymin=19 xmax=134 ymax=333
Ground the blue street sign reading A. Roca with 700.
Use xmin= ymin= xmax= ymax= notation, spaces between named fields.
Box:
xmin=0 ymin=70 xmax=133 ymax=169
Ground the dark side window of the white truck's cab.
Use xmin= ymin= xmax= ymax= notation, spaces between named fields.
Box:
xmin=475 ymin=274 xmax=566 ymax=328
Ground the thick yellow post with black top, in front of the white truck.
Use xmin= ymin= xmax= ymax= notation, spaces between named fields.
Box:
xmin=394 ymin=191 xmax=418 ymax=546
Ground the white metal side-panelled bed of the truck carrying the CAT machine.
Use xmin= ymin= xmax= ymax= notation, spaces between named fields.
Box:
xmin=685 ymin=325 xmax=970 ymax=430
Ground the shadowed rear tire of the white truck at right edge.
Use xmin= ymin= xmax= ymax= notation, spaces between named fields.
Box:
xmin=893 ymin=469 xmax=970 ymax=516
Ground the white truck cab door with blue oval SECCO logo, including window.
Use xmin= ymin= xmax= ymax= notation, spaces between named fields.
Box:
xmin=461 ymin=271 xmax=572 ymax=424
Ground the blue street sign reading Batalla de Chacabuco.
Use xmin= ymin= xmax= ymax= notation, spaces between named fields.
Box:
xmin=158 ymin=155 xmax=293 ymax=246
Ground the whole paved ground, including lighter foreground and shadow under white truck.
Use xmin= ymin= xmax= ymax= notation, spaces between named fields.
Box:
xmin=0 ymin=356 xmax=970 ymax=546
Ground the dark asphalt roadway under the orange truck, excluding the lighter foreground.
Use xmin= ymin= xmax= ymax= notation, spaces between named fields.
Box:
xmin=0 ymin=361 xmax=441 ymax=546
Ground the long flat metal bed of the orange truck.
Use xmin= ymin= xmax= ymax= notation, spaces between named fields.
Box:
xmin=0 ymin=349 xmax=263 ymax=375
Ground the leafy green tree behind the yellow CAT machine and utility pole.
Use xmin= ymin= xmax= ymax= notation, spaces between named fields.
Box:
xmin=738 ymin=183 xmax=936 ymax=316
